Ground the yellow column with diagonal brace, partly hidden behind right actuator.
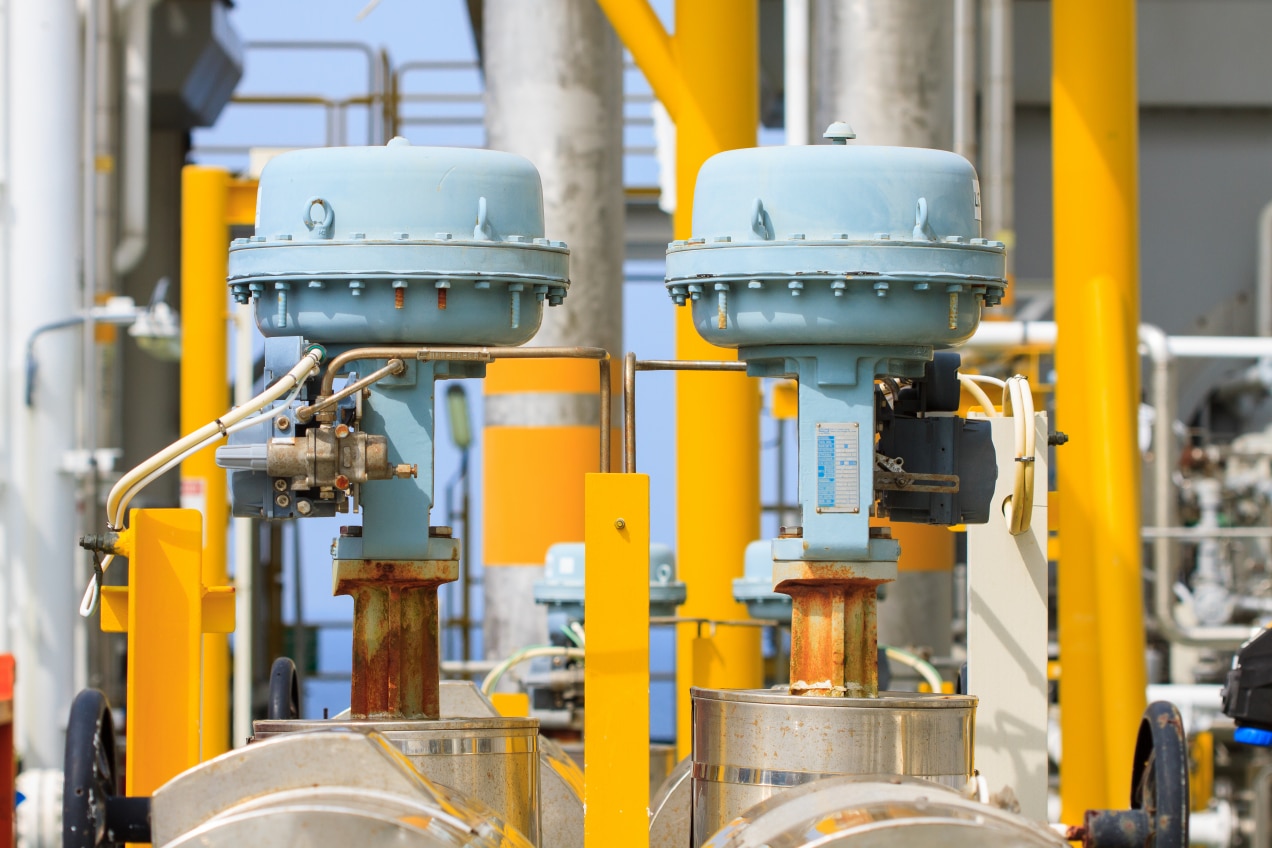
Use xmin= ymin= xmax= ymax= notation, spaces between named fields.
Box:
xmin=673 ymin=0 xmax=761 ymax=756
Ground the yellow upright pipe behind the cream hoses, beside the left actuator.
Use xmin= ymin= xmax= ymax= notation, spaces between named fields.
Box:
xmin=181 ymin=165 xmax=230 ymax=758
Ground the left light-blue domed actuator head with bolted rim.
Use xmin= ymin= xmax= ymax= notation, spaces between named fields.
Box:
xmin=229 ymin=139 xmax=570 ymax=345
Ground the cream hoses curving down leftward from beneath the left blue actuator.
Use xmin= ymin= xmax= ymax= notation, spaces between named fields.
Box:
xmin=80 ymin=347 xmax=323 ymax=618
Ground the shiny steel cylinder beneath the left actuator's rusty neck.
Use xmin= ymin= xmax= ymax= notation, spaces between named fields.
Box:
xmin=254 ymin=718 xmax=543 ymax=845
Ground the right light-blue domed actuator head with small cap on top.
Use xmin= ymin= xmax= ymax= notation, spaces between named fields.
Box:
xmin=667 ymin=123 xmax=1006 ymax=347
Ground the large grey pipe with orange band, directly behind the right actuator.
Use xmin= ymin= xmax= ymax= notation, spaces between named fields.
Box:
xmin=813 ymin=0 xmax=965 ymax=656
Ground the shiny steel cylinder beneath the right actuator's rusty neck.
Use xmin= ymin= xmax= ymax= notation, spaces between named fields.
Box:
xmin=691 ymin=689 xmax=976 ymax=845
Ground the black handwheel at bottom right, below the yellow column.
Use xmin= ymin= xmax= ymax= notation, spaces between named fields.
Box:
xmin=1131 ymin=701 xmax=1189 ymax=848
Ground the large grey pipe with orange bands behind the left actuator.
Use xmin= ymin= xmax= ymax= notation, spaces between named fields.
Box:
xmin=482 ymin=0 xmax=625 ymax=657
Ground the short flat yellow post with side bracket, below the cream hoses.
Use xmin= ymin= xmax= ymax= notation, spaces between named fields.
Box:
xmin=102 ymin=510 xmax=234 ymax=796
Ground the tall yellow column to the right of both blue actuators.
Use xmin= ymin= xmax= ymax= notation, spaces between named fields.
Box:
xmin=1051 ymin=0 xmax=1145 ymax=824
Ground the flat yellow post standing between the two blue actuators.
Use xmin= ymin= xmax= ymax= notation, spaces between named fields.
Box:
xmin=583 ymin=474 xmax=649 ymax=848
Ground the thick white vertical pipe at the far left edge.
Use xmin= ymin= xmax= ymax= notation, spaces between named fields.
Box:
xmin=0 ymin=0 xmax=88 ymax=768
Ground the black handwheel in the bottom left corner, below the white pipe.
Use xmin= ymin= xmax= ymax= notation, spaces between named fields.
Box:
xmin=62 ymin=689 xmax=123 ymax=848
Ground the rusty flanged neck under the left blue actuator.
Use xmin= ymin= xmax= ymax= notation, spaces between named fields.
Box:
xmin=335 ymin=559 xmax=458 ymax=718
